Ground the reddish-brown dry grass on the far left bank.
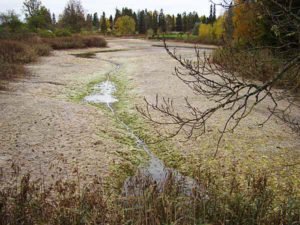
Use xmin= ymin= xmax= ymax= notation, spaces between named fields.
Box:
xmin=0 ymin=36 xmax=107 ymax=89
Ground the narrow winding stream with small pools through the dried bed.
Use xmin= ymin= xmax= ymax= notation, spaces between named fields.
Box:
xmin=84 ymin=60 xmax=197 ymax=196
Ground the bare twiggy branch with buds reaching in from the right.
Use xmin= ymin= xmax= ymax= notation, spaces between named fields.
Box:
xmin=137 ymin=0 xmax=300 ymax=156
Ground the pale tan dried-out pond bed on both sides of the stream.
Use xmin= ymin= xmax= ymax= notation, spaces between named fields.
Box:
xmin=0 ymin=39 xmax=300 ymax=185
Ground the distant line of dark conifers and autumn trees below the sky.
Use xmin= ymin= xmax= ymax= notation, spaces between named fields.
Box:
xmin=0 ymin=0 xmax=216 ymax=37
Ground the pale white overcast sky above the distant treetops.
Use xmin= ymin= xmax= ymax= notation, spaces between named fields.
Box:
xmin=0 ymin=0 xmax=221 ymax=17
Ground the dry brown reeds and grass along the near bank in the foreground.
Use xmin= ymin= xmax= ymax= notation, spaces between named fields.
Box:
xmin=0 ymin=155 xmax=300 ymax=225
